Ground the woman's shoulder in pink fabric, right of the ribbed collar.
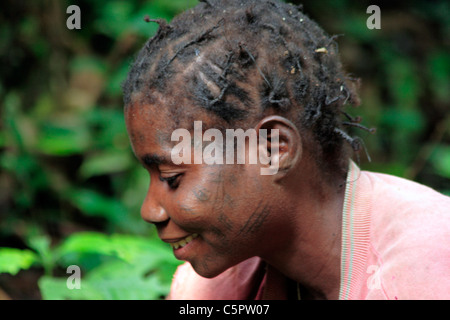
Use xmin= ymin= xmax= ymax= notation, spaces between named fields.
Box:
xmin=366 ymin=173 xmax=450 ymax=299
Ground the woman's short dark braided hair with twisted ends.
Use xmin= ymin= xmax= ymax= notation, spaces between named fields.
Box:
xmin=123 ymin=0 xmax=373 ymax=180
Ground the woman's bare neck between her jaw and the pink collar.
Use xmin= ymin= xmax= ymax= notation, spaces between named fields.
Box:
xmin=262 ymin=160 xmax=345 ymax=299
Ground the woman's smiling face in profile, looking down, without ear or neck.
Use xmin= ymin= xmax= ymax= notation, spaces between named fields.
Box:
xmin=125 ymin=106 xmax=279 ymax=277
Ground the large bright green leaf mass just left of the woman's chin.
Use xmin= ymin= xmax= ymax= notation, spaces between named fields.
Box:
xmin=44 ymin=232 xmax=181 ymax=300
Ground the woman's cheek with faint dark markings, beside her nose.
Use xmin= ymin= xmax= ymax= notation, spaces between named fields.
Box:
xmin=172 ymin=166 xmax=267 ymax=240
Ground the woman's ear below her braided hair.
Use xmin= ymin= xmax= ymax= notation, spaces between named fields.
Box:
xmin=255 ymin=115 xmax=303 ymax=179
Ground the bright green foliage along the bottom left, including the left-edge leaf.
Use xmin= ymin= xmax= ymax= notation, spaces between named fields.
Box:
xmin=0 ymin=232 xmax=180 ymax=300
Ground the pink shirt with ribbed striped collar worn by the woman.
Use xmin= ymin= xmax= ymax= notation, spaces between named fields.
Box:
xmin=169 ymin=162 xmax=450 ymax=300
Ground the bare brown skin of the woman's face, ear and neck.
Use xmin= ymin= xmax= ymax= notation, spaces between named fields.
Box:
xmin=125 ymin=100 xmax=344 ymax=299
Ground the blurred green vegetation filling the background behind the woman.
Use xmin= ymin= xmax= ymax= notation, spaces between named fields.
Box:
xmin=0 ymin=0 xmax=450 ymax=299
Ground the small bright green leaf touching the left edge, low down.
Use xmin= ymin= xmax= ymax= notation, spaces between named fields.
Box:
xmin=0 ymin=248 xmax=37 ymax=275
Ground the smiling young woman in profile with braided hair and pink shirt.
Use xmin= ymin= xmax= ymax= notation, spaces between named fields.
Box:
xmin=124 ymin=0 xmax=450 ymax=299
